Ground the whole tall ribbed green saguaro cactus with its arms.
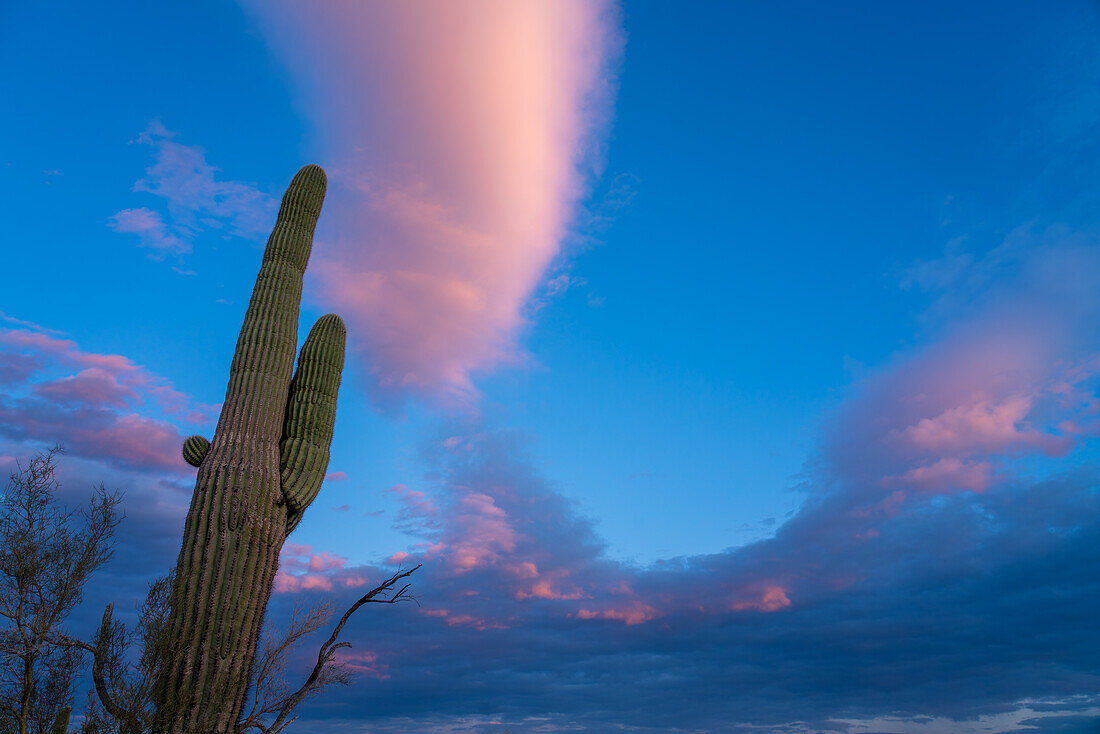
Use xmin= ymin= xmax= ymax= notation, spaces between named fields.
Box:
xmin=154 ymin=165 xmax=345 ymax=734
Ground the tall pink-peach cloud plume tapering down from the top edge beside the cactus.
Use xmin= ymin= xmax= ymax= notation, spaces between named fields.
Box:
xmin=245 ymin=0 xmax=622 ymax=405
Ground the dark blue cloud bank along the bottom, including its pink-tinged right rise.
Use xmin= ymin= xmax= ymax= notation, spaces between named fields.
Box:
xmin=261 ymin=227 xmax=1100 ymax=734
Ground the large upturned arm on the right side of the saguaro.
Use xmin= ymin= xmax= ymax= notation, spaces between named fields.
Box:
xmin=279 ymin=314 xmax=347 ymax=525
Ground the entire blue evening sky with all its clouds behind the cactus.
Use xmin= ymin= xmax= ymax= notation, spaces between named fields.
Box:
xmin=0 ymin=0 xmax=1100 ymax=734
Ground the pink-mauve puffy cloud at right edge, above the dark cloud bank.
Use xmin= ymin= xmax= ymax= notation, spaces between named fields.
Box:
xmin=820 ymin=290 xmax=1100 ymax=521
